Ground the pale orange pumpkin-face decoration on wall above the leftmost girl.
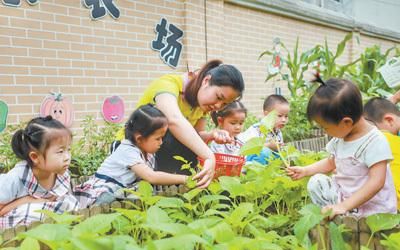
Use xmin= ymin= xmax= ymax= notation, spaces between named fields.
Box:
xmin=40 ymin=93 xmax=73 ymax=127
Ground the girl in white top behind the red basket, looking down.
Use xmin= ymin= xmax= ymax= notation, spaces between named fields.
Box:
xmin=209 ymin=101 xmax=247 ymax=155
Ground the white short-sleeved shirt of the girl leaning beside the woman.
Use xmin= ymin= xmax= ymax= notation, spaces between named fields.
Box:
xmin=96 ymin=139 xmax=155 ymax=187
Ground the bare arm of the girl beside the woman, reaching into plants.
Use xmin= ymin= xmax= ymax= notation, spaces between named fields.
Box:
xmin=131 ymin=164 xmax=188 ymax=185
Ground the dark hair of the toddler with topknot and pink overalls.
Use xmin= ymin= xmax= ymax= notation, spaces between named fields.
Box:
xmin=307 ymin=78 xmax=363 ymax=124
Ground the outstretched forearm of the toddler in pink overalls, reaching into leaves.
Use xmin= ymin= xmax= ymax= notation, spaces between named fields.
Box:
xmin=286 ymin=157 xmax=336 ymax=180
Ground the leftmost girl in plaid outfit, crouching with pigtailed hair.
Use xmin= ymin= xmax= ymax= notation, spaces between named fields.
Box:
xmin=0 ymin=116 xmax=78 ymax=229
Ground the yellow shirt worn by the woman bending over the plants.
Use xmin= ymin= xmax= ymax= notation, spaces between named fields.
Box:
xmin=116 ymin=74 xmax=206 ymax=140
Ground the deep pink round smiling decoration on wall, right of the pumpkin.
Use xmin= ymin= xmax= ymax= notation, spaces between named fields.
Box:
xmin=102 ymin=95 xmax=125 ymax=123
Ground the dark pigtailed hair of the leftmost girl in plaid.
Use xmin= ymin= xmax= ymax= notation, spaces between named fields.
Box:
xmin=11 ymin=116 xmax=72 ymax=166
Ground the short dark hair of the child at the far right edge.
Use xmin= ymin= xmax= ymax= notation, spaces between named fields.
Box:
xmin=364 ymin=97 xmax=400 ymax=122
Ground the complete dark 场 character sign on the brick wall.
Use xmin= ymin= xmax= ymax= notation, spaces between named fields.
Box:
xmin=151 ymin=18 xmax=183 ymax=68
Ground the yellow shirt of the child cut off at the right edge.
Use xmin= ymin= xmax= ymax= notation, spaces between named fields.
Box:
xmin=382 ymin=131 xmax=400 ymax=210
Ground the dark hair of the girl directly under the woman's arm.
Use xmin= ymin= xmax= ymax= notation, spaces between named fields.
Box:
xmin=125 ymin=104 xmax=168 ymax=144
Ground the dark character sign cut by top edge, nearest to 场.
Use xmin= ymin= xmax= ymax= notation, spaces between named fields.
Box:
xmin=83 ymin=0 xmax=120 ymax=20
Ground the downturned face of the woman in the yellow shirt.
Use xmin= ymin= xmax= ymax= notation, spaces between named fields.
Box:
xmin=197 ymin=76 xmax=239 ymax=112
